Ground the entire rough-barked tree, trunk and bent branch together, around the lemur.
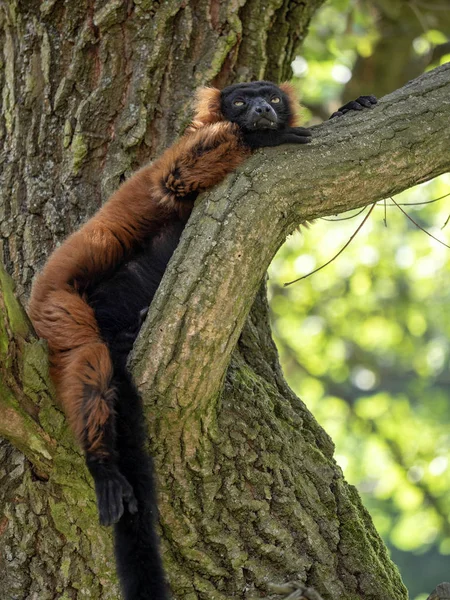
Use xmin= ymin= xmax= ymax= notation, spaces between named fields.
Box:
xmin=0 ymin=1 xmax=449 ymax=600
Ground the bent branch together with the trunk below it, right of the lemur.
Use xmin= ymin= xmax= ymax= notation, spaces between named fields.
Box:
xmin=128 ymin=65 xmax=450 ymax=600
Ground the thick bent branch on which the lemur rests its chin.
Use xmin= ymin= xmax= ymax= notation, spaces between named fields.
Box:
xmin=134 ymin=64 xmax=450 ymax=422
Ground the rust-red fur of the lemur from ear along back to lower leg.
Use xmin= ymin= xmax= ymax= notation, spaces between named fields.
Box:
xmin=29 ymin=88 xmax=249 ymax=456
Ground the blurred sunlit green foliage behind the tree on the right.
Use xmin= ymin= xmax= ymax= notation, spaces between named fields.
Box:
xmin=270 ymin=0 xmax=450 ymax=600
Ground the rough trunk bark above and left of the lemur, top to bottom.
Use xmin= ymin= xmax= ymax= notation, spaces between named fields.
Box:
xmin=0 ymin=0 xmax=330 ymax=600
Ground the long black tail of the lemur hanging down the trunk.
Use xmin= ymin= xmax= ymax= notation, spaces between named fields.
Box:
xmin=114 ymin=367 xmax=169 ymax=600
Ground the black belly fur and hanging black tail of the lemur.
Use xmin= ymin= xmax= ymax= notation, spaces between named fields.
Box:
xmin=88 ymin=220 xmax=184 ymax=600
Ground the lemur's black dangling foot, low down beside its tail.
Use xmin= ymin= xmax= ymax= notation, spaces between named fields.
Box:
xmin=88 ymin=462 xmax=138 ymax=526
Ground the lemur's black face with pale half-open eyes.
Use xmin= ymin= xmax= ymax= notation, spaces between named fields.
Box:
xmin=221 ymin=81 xmax=292 ymax=131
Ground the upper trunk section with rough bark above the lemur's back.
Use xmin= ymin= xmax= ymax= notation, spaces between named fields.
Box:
xmin=0 ymin=0 xmax=323 ymax=298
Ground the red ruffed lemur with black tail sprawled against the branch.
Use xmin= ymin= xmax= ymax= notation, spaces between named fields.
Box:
xmin=29 ymin=81 xmax=376 ymax=600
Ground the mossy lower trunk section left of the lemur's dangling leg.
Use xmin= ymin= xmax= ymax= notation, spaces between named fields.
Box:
xmin=0 ymin=264 xmax=117 ymax=600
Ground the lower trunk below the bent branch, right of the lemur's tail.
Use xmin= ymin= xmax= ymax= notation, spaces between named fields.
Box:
xmin=142 ymin=286 xmax=407 ymax=600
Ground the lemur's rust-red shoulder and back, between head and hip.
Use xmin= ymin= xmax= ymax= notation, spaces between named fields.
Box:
xmin=30 ymin=122 xmax=250 ymax=322
